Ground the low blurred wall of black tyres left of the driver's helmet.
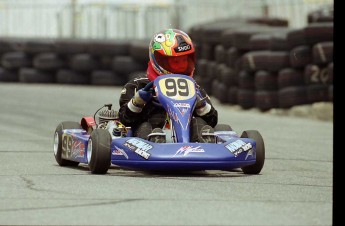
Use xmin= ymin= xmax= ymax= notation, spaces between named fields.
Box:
xmin=0 ymin=38 xmax=148 ymax=86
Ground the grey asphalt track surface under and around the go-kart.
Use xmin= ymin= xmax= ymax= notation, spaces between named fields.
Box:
xmin=0 ymin=83 xmax=333 ymax=226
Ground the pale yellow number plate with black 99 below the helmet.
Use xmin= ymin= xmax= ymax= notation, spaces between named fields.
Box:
xmin=159 ymin=77 xmax=195 ymax=100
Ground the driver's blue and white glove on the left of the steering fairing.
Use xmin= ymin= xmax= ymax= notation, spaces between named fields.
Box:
xmin=128 ymin=82 xmax=153 ymax=113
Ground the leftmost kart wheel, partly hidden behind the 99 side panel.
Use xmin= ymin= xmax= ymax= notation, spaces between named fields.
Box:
xmin=54 ymin=121 xmax=82 ymax=166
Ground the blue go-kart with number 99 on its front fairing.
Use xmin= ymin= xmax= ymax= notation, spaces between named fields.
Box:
xmin=54 ymin=74 xmax=265 ymax=174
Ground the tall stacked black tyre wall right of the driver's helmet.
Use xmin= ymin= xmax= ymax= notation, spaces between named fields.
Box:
xmin=190 ymin=4 xmax=333 ymax=111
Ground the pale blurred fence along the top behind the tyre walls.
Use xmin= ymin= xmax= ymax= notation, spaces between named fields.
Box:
xmin=0 ymin=0 xmax=333 ymax=39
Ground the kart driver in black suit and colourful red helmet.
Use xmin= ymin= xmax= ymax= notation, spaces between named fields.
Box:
xmin=119 ymin=29 xmax=218 ymax=143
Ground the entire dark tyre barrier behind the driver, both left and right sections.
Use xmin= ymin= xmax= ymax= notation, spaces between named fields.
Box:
xmin=0 ymin=5 xmax=333 ymax=111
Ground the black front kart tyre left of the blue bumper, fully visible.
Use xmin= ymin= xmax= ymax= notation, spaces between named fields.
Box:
xmin=87 ymin=129 xmax=111 ymax=174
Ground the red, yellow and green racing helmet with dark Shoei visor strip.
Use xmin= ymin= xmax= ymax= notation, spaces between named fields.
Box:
xmin=149 ymin=29 xmax=195 ymax=77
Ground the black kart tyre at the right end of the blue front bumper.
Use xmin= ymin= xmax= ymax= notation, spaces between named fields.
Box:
xmin=241 ymin=130 xmax=265 ymax=174
